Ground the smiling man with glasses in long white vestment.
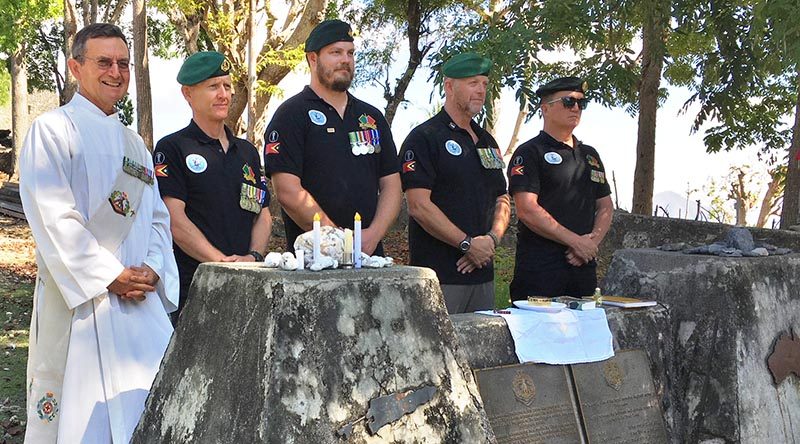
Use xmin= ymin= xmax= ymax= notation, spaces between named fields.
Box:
xmin=20 ymin=23 xmax=178 ymax=444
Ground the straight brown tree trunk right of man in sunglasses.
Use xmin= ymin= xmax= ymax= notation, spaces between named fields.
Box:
xmin=632 ymin=0 xmax=671 ymax=215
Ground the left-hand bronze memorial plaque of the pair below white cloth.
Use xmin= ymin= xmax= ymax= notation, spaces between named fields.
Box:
xmin=474 ymin=364 xmax=581 ymax=444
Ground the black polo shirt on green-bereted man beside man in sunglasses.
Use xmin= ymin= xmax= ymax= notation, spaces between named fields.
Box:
xmin=400 ymin=109 xmax=506 ymax=285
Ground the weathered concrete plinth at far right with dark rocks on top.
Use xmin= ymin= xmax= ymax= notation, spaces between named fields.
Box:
xmin=604 ymin=249 xmax=800 ymax=443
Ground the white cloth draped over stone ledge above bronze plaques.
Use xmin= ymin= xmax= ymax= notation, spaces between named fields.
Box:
xmin=476 ymin=308 xmax=614 ymax=364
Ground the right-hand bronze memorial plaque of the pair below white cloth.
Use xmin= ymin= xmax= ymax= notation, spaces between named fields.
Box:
xmin=572 ymin=350 xmax=667 ymax=444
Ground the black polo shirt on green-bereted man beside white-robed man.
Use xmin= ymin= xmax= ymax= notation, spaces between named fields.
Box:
xmin=153 ymin=120 xmax=269 ymax=302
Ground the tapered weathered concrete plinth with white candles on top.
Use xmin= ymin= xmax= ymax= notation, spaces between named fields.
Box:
xmin=132 ymin=264 xmax=494 ymax=444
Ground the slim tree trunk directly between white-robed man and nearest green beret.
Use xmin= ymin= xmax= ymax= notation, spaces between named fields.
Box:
xmin=133 ymin=0 xmax=153 ymax=151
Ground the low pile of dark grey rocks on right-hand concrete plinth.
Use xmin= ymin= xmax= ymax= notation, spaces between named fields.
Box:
xmin=658 ymin=227 xmax=792 ymax=257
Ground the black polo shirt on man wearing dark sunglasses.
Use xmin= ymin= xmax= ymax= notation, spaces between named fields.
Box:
xmin=508 ymin=131 xmax=611 ymax=259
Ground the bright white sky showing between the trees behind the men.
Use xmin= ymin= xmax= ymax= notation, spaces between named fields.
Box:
xmin=131 ymin=57 xmax=766 ymax=222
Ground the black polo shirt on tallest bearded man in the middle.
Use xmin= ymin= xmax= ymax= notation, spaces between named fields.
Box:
xmin=264 ymin=86 xmax=400 ymax=255
